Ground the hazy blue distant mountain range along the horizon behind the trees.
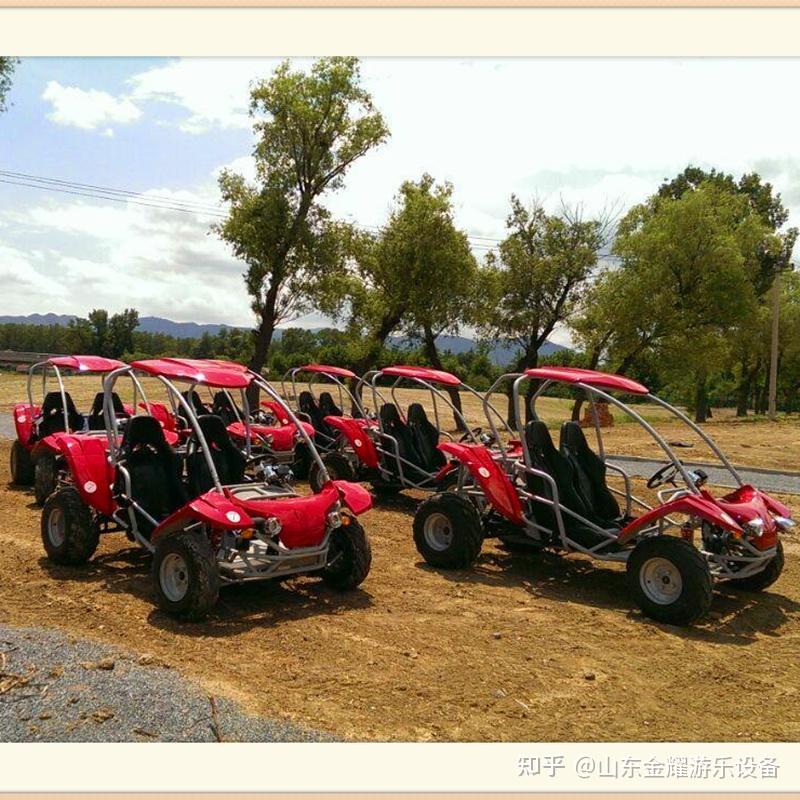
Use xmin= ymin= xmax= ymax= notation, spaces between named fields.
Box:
xmin=0 ymin=314 xmax=566 ymax=366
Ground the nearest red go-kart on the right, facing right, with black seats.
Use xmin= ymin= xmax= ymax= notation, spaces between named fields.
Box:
xmin=414 ymin=367 xmax=794 ymax=625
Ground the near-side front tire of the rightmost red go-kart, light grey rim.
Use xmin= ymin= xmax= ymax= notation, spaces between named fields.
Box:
xmin=626 ymin=536 xmax=712 ymax=625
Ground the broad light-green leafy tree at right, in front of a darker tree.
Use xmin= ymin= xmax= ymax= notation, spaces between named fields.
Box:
xmin=575 ymin=182 xmax=780 ymax=421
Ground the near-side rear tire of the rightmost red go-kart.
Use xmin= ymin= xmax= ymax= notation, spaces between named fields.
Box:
xmin=414 ymin=492 xmax=483 ymax=569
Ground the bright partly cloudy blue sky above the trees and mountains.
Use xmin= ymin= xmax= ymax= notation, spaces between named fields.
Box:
xmin=0 ymin=58 xmax=800 ymax=340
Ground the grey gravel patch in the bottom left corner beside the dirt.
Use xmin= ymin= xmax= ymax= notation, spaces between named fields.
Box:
xmin=0 ymin=625 xmax=333 ymax=742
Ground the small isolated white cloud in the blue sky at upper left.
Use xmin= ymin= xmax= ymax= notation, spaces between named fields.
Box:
xmin=42 ymin=81 xmax=142 ymax=136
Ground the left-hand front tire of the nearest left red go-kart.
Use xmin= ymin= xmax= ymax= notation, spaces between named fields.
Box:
xmin=152 ymin=531 xmax=219 ymax=621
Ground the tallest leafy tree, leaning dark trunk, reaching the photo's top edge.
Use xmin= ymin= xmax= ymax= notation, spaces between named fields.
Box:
xmin=215 ymin=57 xmax=388 ymax=384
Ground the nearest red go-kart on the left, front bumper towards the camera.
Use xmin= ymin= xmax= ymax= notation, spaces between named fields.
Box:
xmin=41 ymin=358 xmax=371 ymax=619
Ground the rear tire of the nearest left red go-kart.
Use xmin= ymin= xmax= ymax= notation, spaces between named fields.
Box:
xmin=42 ymin=487 xmax=100 ymax=565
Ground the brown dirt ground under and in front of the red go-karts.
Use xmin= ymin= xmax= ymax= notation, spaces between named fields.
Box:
xmin=0 ymin=441 xmax=800 ymax=741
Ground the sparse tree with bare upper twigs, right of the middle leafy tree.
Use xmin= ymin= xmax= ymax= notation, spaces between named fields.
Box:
xmin=480 ymin=195 xmax=609 ymax=417
